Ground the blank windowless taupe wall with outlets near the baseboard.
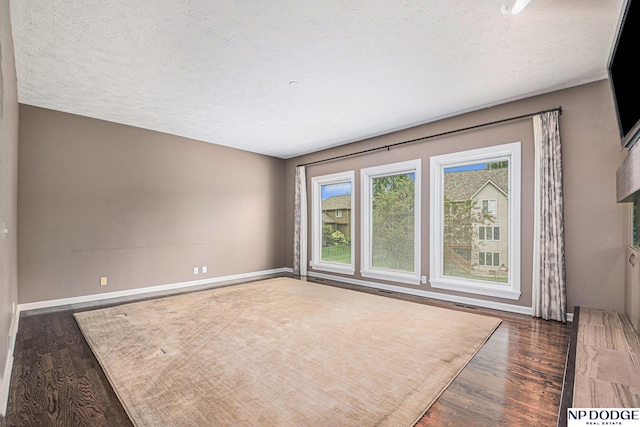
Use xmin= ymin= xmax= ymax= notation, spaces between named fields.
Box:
xmin=18 ymin=105 xmax=289 ymax=303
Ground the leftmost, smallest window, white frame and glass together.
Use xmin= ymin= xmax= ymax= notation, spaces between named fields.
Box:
xmin=311 ymin=171 xmax=355 ymax=274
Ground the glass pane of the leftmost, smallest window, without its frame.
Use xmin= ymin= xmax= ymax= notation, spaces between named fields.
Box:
xmin=321 ymin=182 xmax=351 ymax=264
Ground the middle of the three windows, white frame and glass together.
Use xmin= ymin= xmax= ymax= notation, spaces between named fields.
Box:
xmin=361 ymin=160 xmax=420 ymax=285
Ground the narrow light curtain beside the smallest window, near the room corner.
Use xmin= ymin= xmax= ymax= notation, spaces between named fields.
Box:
xmin=293 ymin=166 xmax=307 ymax=276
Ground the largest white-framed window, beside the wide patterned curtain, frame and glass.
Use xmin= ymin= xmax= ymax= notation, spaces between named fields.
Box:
xmin=430 ymin=142 xmax=521 ymax=299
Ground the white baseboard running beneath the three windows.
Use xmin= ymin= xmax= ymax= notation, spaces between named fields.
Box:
xmin=307 ymin=271 xmax=573 ymax=322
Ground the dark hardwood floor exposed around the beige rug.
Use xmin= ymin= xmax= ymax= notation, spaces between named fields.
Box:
xmin=0 ymin=279 xmax=571 ymax=427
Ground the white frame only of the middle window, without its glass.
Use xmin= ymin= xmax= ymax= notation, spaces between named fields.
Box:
xmin=360 ymin=159 xmax=422 ymax=285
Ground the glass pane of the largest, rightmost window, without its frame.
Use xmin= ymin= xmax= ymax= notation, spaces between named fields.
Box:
xmin=442 ymin=161 xmax=510 ymax=282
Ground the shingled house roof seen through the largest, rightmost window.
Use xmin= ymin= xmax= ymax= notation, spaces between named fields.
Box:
xmin=444 ymin=168 xmax=509 ymax=201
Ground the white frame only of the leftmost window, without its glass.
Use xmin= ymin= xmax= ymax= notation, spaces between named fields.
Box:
xmin=311 ymin=171 xmax=356 ymax=275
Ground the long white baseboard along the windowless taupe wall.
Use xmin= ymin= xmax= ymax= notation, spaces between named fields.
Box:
xmin=18 ymin=267 xmax=293 ymax=311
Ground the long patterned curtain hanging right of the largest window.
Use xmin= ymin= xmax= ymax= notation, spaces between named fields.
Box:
xmin=533 ymin=111 xmax=567 ymax=322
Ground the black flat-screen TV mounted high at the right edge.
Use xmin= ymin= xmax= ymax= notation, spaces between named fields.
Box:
xmin=608 ymin=0 xmax=640 ymax=148
